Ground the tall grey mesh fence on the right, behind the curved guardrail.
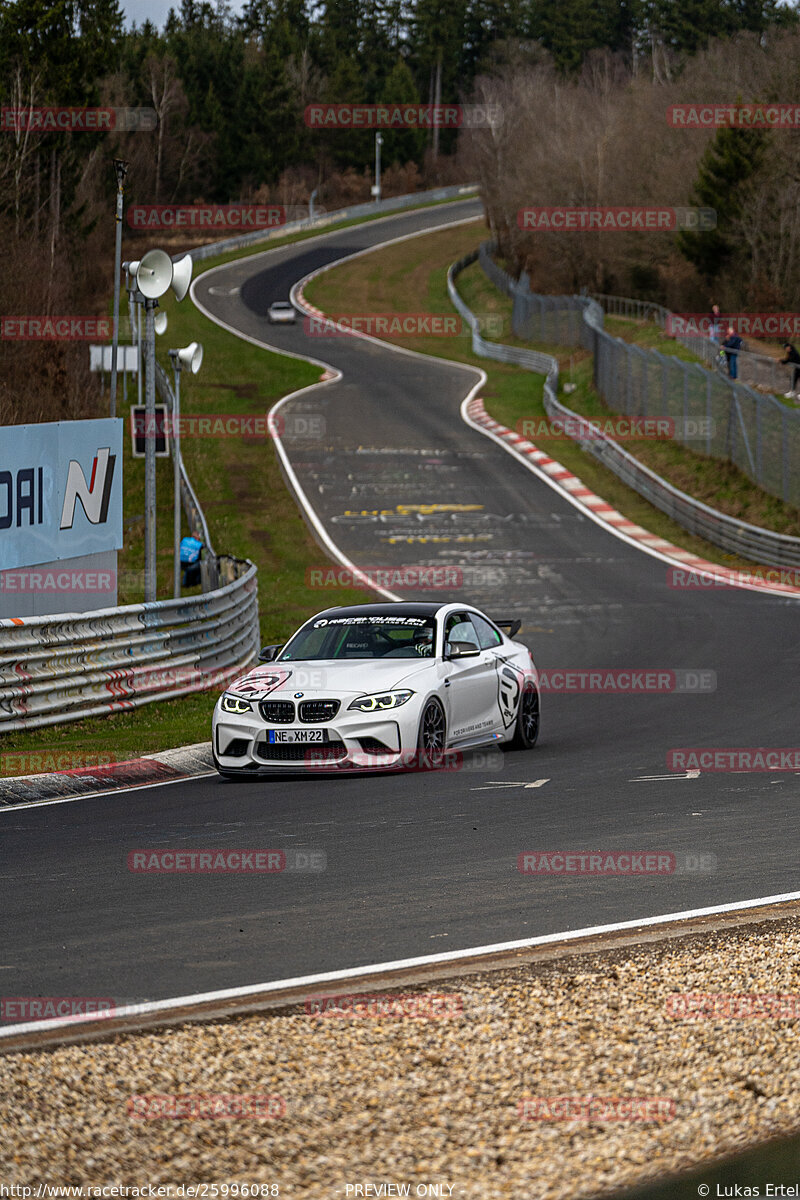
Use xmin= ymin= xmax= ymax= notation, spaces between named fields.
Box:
xmin=480 ymin=244 xmax=800 ymax=506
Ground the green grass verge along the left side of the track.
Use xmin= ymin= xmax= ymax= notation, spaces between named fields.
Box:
xmin=0 ymin=202 xmax=474 ymax=758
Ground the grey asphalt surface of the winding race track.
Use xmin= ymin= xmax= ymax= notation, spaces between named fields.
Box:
xmin=0 ymin=200 xmax=800 ymax=1022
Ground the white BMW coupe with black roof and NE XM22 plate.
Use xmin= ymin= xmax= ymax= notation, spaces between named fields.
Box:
xmin=212 ymin=601 xmax=540 ymax=776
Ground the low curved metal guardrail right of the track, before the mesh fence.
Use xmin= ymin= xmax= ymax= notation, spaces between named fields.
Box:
xmin=447 ymin=246 xmax=800 ymax=566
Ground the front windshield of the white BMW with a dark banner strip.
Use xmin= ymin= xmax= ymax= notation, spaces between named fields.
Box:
xmin=277 ymin=612 xmax=435 ymax=662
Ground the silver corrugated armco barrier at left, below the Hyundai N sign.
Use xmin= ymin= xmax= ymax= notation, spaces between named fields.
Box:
xmin=0 ymin=559 xmax=259 ymax=734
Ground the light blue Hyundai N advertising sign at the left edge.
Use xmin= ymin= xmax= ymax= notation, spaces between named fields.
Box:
xmin=0 ymin=418 xmax=122 ymax=570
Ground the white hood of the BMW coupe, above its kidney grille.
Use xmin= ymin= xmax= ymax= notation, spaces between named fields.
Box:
xmin=225 ymin=659 xmax=435 ymax=700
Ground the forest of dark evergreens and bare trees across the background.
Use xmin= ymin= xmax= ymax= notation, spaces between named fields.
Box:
xmin=0 ymin=0 xmax=800 ymax=424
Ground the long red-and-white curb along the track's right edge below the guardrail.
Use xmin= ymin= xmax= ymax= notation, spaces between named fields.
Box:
xmin=462 ymin=396 xmax=800 ymax=598
